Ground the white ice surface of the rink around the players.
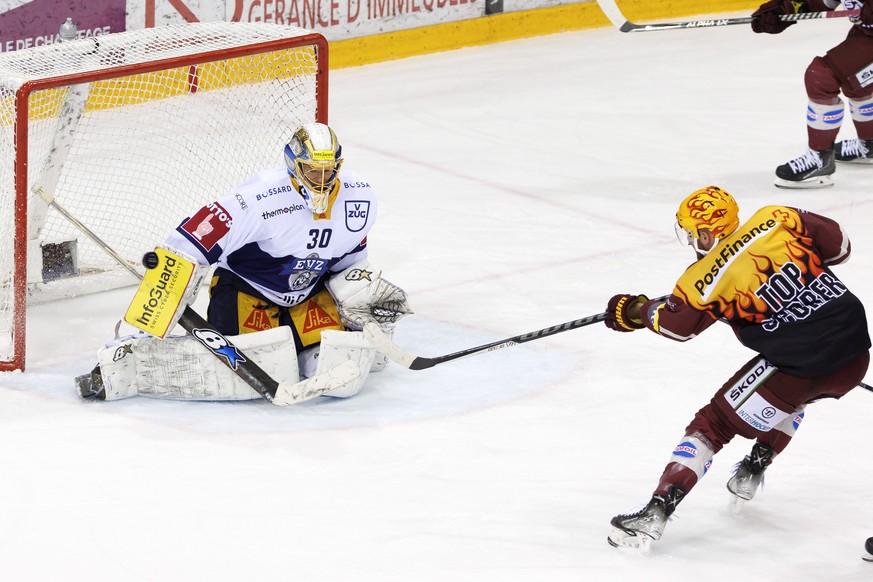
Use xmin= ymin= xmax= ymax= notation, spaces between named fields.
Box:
xmin=0 ymin=13 xmax=873 ymax=582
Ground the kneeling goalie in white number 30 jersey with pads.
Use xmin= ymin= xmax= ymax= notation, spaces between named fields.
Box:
xmin=76 ymin=123 xmax=412 ymax=400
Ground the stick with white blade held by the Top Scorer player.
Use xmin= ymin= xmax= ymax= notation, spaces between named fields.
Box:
xmin=364 ymin=295 xmax=669 ymax=370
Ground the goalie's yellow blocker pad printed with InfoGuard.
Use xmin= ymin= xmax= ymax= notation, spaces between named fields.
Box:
xmin=124 ymin=247 xmax=205 ymax=338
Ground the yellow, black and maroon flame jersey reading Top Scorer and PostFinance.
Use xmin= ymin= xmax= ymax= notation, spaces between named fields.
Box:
xmin=643 ymin=206 xmax=870 ymax=377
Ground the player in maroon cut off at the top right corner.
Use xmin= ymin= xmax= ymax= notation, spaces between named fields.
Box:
xmin=752 ymin=0 xmax=873 ymax=188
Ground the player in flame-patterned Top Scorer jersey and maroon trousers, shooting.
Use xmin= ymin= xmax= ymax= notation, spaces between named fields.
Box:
xmin=605 ymin=186 xmax=870 ymax=549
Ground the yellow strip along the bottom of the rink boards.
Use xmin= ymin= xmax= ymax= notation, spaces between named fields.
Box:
xmin=3 ymin=0 xmax=760 ymax=123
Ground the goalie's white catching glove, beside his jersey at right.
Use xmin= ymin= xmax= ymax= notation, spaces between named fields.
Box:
xmin=326 ymin=261 xmax=413 ymax=331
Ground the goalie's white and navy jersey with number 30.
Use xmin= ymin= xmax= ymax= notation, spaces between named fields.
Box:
xmin=166 ymin=168 xmax=376 ymax=306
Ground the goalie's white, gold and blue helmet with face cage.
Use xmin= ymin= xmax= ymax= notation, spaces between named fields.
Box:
xmin=285 ymin=123 xmax=343 ymax=214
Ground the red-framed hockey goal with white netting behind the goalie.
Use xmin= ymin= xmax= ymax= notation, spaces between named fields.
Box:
xmin=0 ymin=22 xmax=327 ymax=370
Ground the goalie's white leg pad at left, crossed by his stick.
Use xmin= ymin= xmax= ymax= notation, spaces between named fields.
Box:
xmin=98 ymin=326 xmax=299 ymax=400
